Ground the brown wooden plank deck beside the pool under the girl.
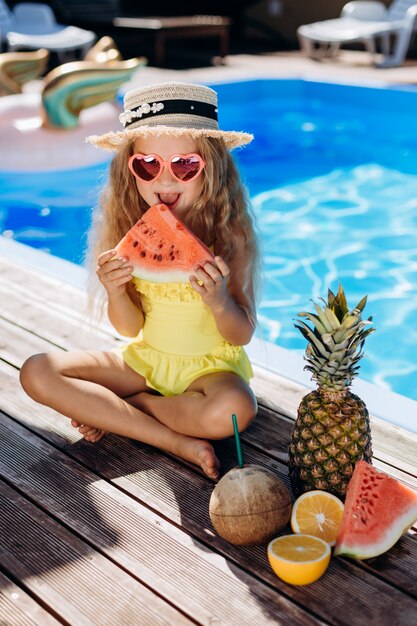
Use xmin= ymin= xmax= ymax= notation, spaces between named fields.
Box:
xmin=0 ymin=251 xmax=417 ymax=626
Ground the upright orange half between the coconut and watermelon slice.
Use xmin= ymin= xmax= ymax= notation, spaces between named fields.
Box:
xmin=291 ymin=491 xmax=344 ymax=546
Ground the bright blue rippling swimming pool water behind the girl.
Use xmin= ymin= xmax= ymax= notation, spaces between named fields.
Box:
xmin=0 ymin=80 xmax=417 ymax=400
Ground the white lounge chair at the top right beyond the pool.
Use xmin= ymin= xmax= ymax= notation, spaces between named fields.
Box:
xmin=297 ymin=0 xmax=417 ymax=67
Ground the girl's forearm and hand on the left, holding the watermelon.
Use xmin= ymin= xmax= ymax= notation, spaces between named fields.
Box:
xmin=97 ymin=250 xmax=144 ymax=337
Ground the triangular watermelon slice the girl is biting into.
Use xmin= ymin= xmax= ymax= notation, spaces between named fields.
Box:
xmin=116 ymin=204 xmax=214 ymax=283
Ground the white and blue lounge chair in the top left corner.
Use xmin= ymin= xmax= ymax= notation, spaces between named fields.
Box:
xmin=0 ymin=0 xmax=96 ymax=60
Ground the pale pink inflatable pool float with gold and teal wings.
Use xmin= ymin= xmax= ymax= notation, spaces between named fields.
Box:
xmin=0 ymin=37 xmax=146 ymax=172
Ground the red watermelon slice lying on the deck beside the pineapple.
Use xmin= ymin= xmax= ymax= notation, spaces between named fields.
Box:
xmin=334 ymin=461 xmax=417 ymax=559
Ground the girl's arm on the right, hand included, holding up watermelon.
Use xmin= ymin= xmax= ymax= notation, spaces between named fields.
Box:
xmin=190 ymin=244 xmax=256 ymax=346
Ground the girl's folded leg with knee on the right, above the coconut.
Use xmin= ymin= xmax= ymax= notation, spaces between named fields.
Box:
xmin=126 ymin=372 xmax=257 ymax=439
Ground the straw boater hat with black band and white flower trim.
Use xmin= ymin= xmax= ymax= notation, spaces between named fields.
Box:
xmin=87 ymin=82 xmax=253 ymax=150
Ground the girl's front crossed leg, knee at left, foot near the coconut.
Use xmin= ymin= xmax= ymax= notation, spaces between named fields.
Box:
xmin=21 ymin=352 xmax=219 ymax=478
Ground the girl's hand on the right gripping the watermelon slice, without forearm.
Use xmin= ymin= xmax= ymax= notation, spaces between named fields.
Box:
xmin=190 ymin=256 xmax=230 ymax=310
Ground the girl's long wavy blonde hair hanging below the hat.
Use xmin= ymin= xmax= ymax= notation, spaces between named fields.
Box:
xmin=87 ymin=137 xmax=260 ymax=314
